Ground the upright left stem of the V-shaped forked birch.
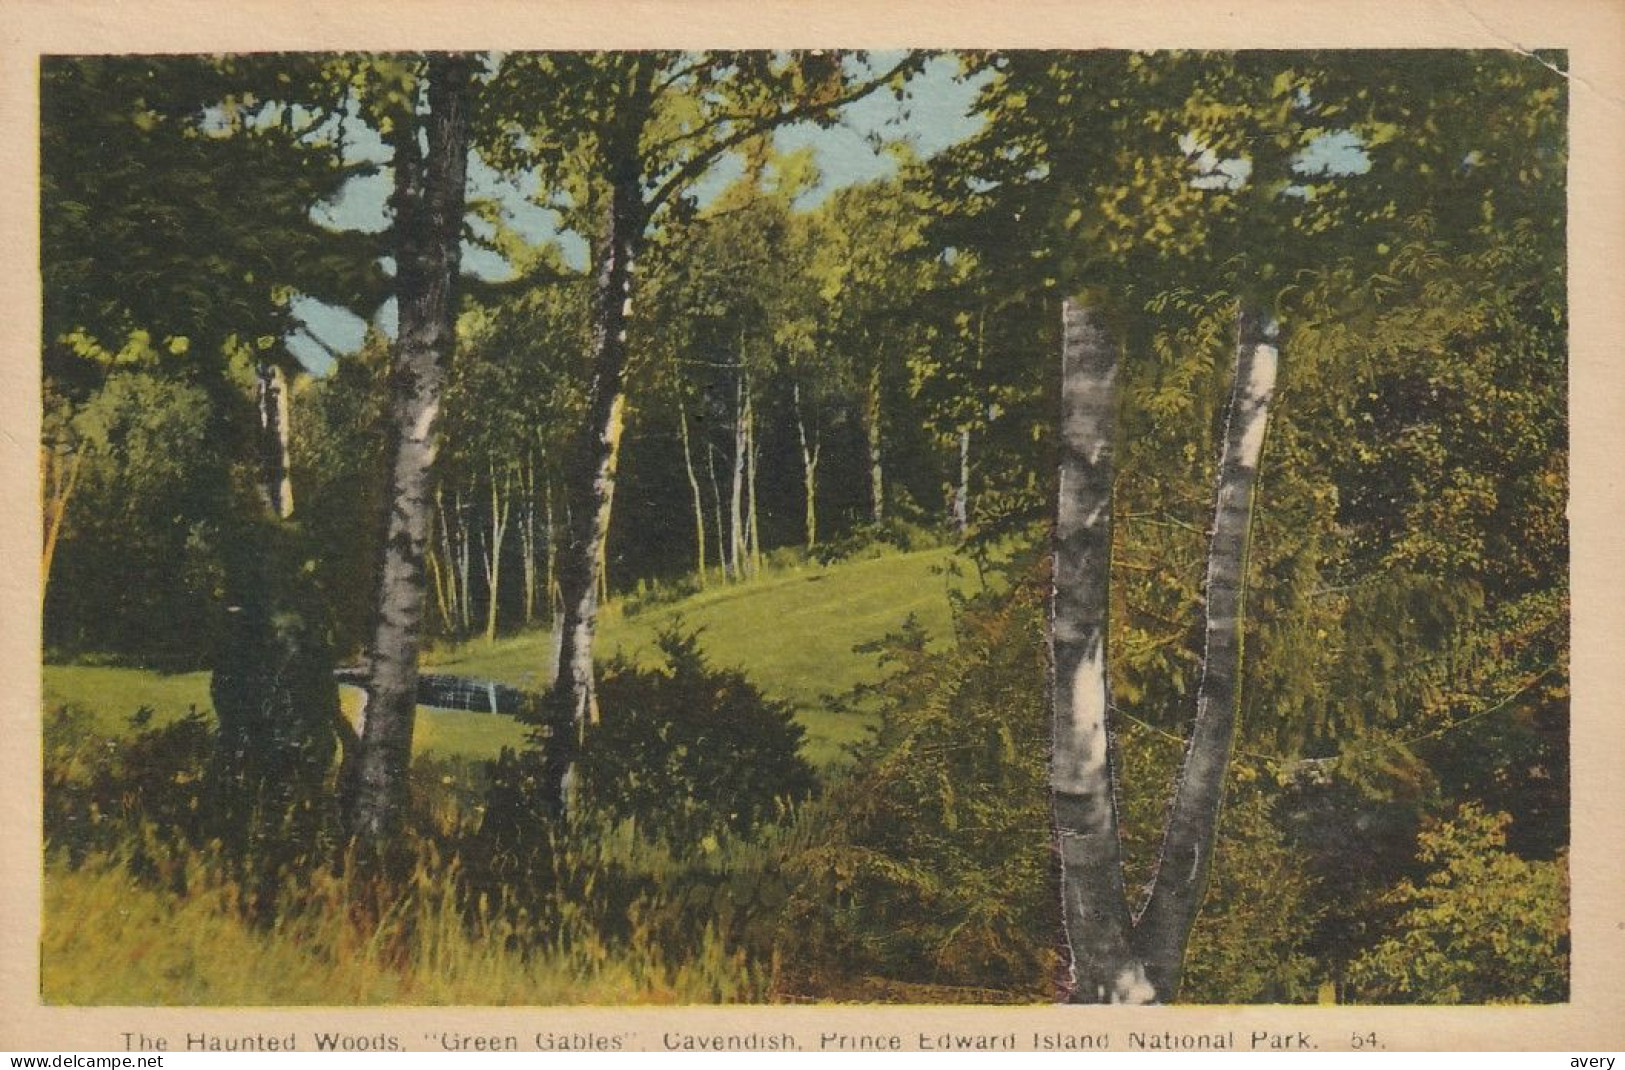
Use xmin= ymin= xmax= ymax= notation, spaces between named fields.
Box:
xmin=1050 ymin=301 xmax=1152 ymax=1003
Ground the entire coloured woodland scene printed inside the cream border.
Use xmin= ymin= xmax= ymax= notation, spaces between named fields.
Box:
xmin=39 ymin=50 xmax=1570 ymax=1005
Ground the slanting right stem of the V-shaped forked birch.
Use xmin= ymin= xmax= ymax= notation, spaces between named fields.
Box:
xmin=1139 ymin=312 xmax=1281 ymax=1000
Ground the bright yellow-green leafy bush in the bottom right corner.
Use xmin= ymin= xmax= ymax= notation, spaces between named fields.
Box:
xmin=1349 ymin=803 xmax=1568 ymax=1003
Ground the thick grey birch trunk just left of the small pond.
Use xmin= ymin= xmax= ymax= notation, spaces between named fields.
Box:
xmin=346 ymin=55 xmax=471 ymax=842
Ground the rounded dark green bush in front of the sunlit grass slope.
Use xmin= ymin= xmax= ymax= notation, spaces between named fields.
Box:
xmin=580 ymin=623 xmax=816 ymax=847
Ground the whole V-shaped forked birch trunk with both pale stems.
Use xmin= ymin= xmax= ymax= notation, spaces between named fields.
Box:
xmin=1051 ymin=301 xmax=1279 ymax=1003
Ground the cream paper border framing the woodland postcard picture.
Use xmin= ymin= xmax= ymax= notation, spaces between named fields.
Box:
xmin=0 ymin=0 xmax=1625 ymax=1050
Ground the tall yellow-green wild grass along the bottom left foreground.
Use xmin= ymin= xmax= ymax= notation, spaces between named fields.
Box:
xmin=41 ymin=850 xmax=772 ymax=1005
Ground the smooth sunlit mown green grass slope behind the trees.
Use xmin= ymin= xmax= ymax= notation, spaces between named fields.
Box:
xmin=44 ymin=550 xmax=964 ymax=766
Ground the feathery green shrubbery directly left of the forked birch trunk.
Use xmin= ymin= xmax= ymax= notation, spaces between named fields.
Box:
xmin=783 ymin=582 xmax=1056 ymax=998
